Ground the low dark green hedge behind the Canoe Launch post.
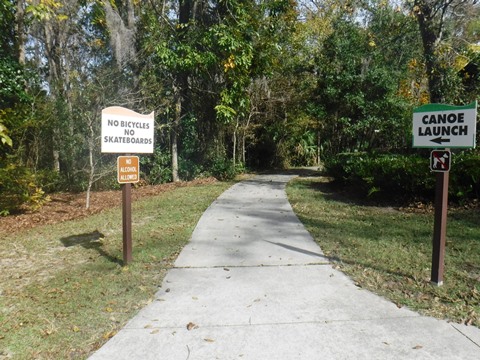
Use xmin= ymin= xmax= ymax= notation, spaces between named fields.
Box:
xmin=325 ymin=152 xmax=480 ymax=202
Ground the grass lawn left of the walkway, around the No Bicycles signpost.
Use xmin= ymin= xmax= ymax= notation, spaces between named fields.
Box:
xmin=0 ymin=182 xmax=231 ymax=359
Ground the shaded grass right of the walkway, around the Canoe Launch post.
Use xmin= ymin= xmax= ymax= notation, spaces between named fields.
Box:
xmin=287 ymin=178 xmax=480 ymax=327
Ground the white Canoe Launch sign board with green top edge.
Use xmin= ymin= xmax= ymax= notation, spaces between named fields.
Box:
xmin=413 ymin=101 xmax=477 ymax=148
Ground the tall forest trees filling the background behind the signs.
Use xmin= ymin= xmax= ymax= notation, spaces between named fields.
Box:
xmin=0 ymin=0 xmax=480 ymax=214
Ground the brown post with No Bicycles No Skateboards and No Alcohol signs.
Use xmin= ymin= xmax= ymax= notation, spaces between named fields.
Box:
xmin=101 ymin=106 xmax=154 ymax=265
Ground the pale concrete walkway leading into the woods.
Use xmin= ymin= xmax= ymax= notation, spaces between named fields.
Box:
xmin=91 ymin=175 xmax=480 ymax=360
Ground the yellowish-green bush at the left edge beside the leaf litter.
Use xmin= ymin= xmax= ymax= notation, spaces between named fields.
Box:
xmin=0 ymin=163 xmax=49 ymax=216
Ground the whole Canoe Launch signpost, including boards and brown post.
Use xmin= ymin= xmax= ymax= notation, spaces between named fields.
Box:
xmin=413 ymin=101 xmax=477 ymax=286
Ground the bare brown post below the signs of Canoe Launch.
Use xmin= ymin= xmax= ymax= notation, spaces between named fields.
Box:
xmin=431 ymin=171 xmax=449 ymax=286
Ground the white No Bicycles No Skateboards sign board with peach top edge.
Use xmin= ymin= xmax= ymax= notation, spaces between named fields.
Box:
xmin=102 ymin=106 xmax=154 ymax=154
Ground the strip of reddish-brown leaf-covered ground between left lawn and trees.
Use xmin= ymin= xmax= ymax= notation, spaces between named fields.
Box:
xmin=0 ymin=178 xmax=216 ymax=234
